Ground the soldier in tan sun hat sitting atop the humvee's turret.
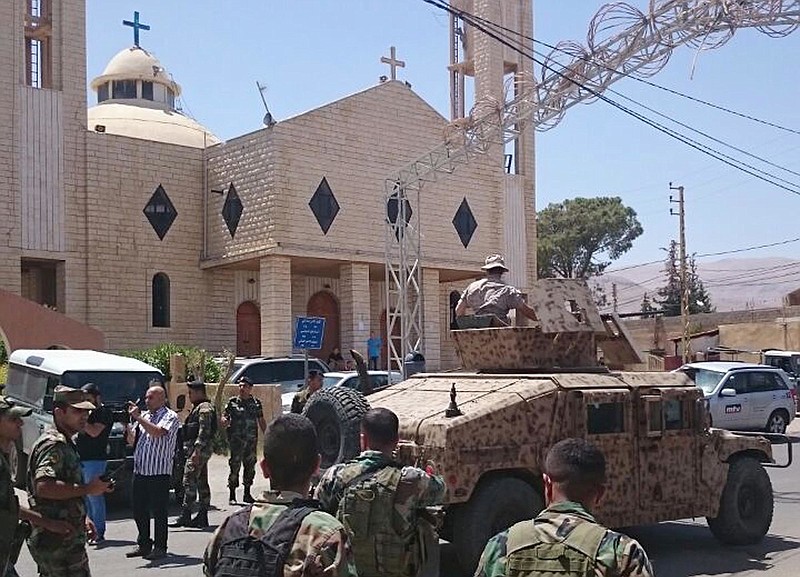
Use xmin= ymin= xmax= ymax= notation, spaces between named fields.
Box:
xmin=456 ymin=254 xmax=538 ymax=324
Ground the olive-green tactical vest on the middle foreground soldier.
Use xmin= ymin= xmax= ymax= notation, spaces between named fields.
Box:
xmin=336 ymin=463 xmax=422 ymax=577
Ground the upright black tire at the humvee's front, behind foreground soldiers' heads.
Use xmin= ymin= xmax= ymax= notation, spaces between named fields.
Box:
xmin=303 ymin=387 xmax=370 ymax=469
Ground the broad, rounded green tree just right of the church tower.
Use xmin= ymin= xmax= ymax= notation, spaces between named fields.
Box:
xmin=537 ymin=196 xmax=643 ymax=278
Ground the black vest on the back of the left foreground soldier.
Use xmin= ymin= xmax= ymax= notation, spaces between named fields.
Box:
xmin=210 ymin=499 xmax=319 ymax=577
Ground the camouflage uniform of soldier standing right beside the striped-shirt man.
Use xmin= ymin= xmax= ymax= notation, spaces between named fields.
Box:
xmin=183 ymin=399 xmax=217 ymax=511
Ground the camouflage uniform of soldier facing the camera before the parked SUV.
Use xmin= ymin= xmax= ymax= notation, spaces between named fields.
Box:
xmin=222 ymin=397 xmax=264 ymax=489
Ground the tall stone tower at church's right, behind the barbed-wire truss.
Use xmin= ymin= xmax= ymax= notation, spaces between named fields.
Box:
xmin=449 ymin=0 xmax=536 ymax=287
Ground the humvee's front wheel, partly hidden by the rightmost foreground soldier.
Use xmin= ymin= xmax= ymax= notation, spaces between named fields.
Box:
xmin=453 ymin=477 xmax=544 ymax=575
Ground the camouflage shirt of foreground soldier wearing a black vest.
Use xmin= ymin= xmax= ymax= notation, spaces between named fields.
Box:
xmin=203 ymin=491 xmax=357 ymax=577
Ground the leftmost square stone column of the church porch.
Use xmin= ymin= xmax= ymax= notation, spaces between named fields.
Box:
xmin=258 ymin=256 xmax=292 ymax=356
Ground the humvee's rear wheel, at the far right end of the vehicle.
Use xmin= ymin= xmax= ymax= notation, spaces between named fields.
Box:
xmin=708 ymin=457 xmax=774 ymax=545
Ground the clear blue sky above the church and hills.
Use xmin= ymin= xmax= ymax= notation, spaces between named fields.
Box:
xmin=87 ymin=0 xmax=800 ymax=267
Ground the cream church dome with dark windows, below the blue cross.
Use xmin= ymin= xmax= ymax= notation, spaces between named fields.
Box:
xmin=87 ymin=46 xmax=219 ymax=148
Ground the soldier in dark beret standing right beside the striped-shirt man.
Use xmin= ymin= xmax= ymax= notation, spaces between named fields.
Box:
xmin=170 ymin=381 xmax=217 ymax=529
